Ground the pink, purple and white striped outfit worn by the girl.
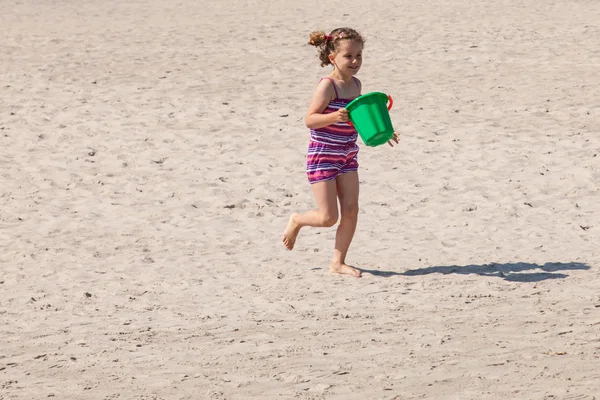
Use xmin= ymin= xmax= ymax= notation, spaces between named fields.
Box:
xmin=306 ymin=77 xmax=358 ymax=184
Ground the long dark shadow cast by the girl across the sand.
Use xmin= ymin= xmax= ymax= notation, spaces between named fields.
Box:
xmin=361 ymin=262 xmax=590 ymax=282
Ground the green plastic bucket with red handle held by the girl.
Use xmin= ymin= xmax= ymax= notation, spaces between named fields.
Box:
xmin=346 ymin=92 xmax=394 ymax=147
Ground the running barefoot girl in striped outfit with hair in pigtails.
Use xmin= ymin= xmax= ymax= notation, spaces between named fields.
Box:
xmin=283 ymin=28 xmax=398 ymax=277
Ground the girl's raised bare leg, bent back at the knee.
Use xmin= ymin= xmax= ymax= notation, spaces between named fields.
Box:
xmin=283 ymin=180 xmax=338 ymax=250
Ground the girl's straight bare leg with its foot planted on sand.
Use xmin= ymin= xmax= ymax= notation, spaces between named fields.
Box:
xmin=329 ymin=171 xmax=361 ymax=277
